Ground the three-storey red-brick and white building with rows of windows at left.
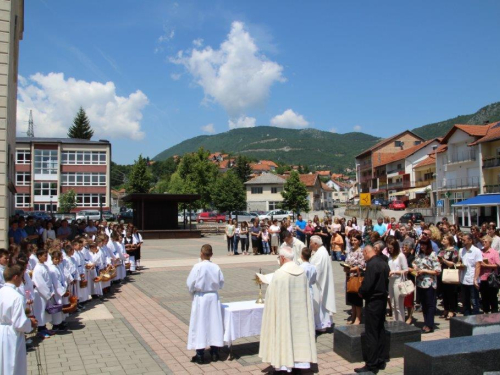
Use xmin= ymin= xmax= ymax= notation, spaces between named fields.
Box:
xmin=14 ymin=137 xmax=111 ymax=212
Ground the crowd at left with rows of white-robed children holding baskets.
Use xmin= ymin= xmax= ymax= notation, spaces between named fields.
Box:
xmin=0 ymin=217 xmax=143 ymax=374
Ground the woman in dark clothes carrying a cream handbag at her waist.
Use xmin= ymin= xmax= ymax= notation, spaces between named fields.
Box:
xmin=438 ymin=236 xmax=458 ymax=320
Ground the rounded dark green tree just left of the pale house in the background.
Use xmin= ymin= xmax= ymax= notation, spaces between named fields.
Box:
xmin=212 ymin=170 xmax=247 ymax=212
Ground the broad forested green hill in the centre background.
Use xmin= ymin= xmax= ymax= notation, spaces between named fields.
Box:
xmin=153 ymin=126 xmax=380 ymax=172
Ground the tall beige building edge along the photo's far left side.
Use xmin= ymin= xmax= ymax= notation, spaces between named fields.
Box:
xmin=0 ymin=0 xmax=24 ymax=248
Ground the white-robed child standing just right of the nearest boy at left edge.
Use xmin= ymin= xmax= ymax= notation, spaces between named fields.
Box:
xmin=33 ymin=249 xmax=55 ymax=339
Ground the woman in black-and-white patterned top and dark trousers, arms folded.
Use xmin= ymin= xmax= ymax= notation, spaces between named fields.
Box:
xmin=413 ymin=238 xmax=441 ymax=333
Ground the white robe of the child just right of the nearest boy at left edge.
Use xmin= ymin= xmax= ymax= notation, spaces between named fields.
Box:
xmin=33 ymin=263 xmax=54 ymax=327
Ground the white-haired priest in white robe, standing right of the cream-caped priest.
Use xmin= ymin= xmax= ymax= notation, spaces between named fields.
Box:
xmin=309 ymin=236 xmax=337 ymax=332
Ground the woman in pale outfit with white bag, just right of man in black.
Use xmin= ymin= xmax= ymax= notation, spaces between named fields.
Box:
xmin=387 ymin=237 xmax=408 ymax=322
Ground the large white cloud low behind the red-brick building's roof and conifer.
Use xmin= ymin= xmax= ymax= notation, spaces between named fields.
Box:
xmin=17 ymin=73 xmax=148 ymax=140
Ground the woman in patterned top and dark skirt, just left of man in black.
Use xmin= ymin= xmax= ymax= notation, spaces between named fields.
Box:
xmin=344 ymin=234 xmax=366 ymax=324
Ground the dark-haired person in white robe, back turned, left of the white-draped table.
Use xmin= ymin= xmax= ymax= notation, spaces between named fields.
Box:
xmin=187 ymin=245 xmax=224 ymax=364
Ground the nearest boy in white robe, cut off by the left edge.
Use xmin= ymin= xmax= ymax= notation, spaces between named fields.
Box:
xmin=0 ymin=264 xmax=38 ymax=374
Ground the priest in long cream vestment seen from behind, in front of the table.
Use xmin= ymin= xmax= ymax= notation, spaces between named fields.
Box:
xmin=259 ymin=246 xmax=318 ymax=372
